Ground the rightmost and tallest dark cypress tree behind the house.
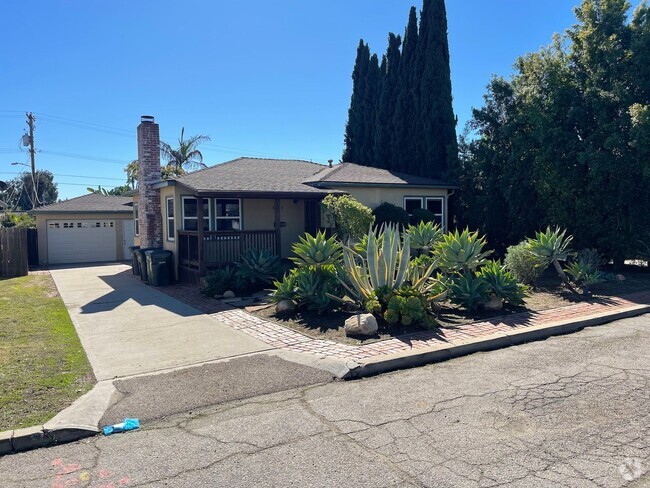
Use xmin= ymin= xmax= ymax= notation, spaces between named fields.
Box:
xmin=409 ymin=0 xmax=458 ymax=177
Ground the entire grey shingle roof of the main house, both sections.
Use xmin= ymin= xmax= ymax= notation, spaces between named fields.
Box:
xmin=165 ymin=157 xmax=455 ymax=196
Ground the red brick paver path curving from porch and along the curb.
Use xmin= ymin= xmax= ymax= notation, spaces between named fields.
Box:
xmin=153 ymin=278 xmax=650 ymax=361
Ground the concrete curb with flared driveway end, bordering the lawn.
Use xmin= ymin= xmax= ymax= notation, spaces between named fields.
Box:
xmin=0 ymin=381 xmax=116 ymax=456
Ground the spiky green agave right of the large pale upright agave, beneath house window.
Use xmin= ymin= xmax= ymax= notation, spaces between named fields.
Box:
xmin=433 ymin=229 xmax=492 ymax=273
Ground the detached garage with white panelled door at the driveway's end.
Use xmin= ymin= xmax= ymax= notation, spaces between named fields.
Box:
xmin=34 ymin=193 xmax=134 ymax=265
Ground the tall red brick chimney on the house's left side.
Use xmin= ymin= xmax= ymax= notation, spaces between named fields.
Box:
xmin=138 ymin=115 xmax=163 ymax=248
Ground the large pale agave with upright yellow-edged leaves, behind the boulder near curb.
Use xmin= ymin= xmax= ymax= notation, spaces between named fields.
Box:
xmin=339 ymin=225 xmax=435 ymax=303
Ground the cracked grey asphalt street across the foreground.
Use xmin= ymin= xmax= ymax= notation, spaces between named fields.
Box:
xmin=0 ymin=315 xmax=650 ymax=488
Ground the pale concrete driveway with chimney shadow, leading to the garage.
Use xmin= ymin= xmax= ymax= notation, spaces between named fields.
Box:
xmin=51 ymin=264 xmax=270 ymax=381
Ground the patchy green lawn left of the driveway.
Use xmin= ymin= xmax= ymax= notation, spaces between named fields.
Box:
xmin=0 ymin=275 xmax=95 ymax=431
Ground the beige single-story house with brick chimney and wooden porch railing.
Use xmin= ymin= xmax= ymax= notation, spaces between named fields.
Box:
xmin=133 ymin=116 xmax=455 ymax=281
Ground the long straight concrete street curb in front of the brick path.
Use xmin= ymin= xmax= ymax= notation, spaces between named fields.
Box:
xmin=342 ymin=305 xmax=650 ymax=380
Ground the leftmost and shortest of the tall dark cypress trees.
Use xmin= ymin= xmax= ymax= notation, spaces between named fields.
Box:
xmin=343 ymin=39 xmax=370 ymax=163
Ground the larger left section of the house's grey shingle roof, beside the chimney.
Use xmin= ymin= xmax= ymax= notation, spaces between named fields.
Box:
xmin=173 ymin=158 xmax=342 ymax=195
